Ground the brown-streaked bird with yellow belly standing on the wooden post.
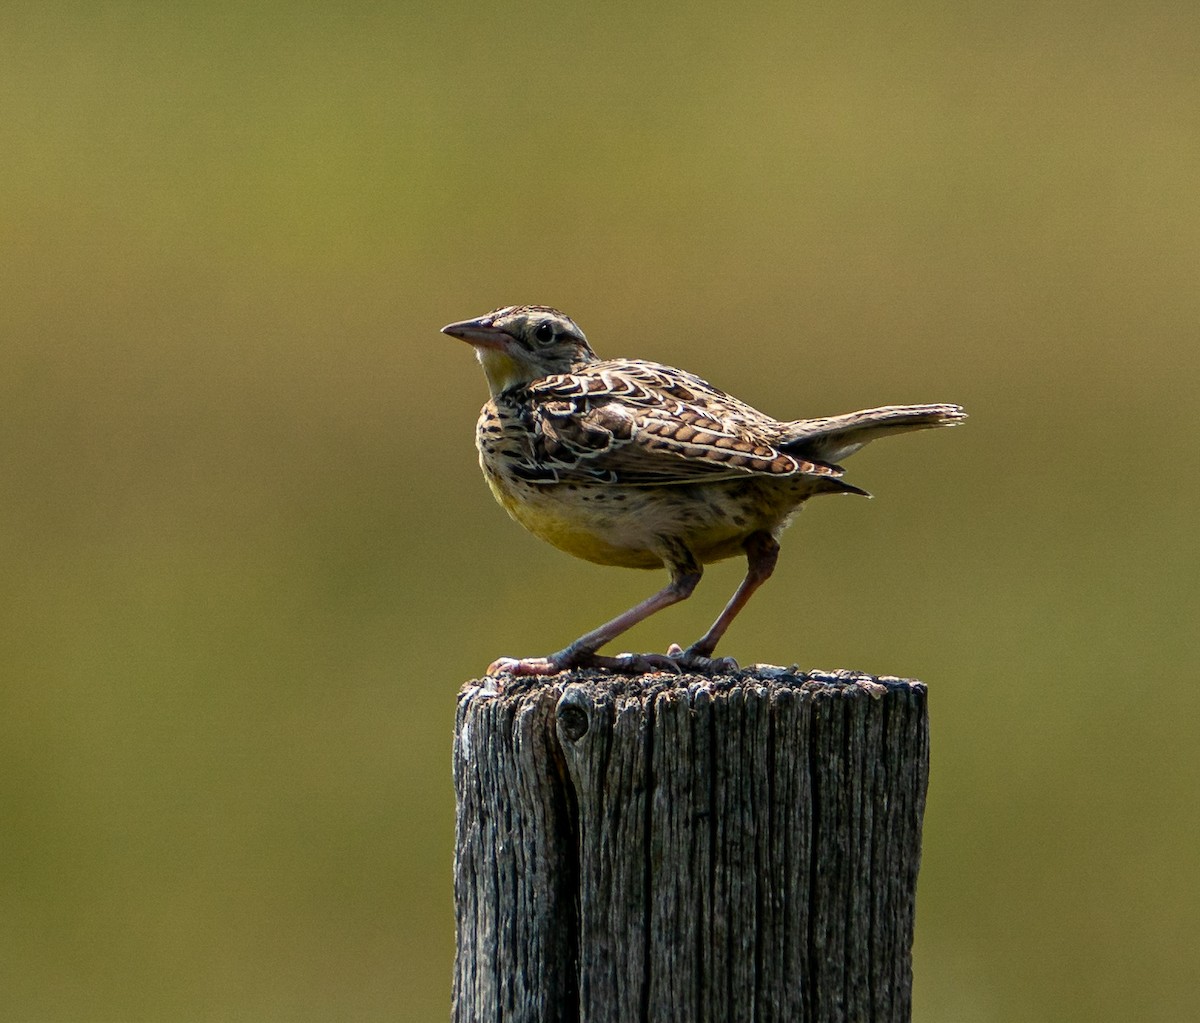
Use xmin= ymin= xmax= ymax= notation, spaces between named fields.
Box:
xmin=442 ymin=305 xmax=966 ymax=676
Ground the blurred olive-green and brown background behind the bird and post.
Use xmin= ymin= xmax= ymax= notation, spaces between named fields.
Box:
xmin=0 ymin=0 xmax=1200 ymax=1021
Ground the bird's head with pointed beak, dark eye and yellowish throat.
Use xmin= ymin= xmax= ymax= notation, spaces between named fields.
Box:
xmin=442 ymin=305 xmax=596 ymax=395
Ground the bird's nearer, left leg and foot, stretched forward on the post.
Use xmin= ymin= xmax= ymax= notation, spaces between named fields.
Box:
xmin=487 ymin=543 xmax=700 ymax=675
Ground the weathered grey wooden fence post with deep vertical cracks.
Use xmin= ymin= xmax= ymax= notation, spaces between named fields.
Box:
xmin=454 ymin=666 xmax=929 ymax=1023
